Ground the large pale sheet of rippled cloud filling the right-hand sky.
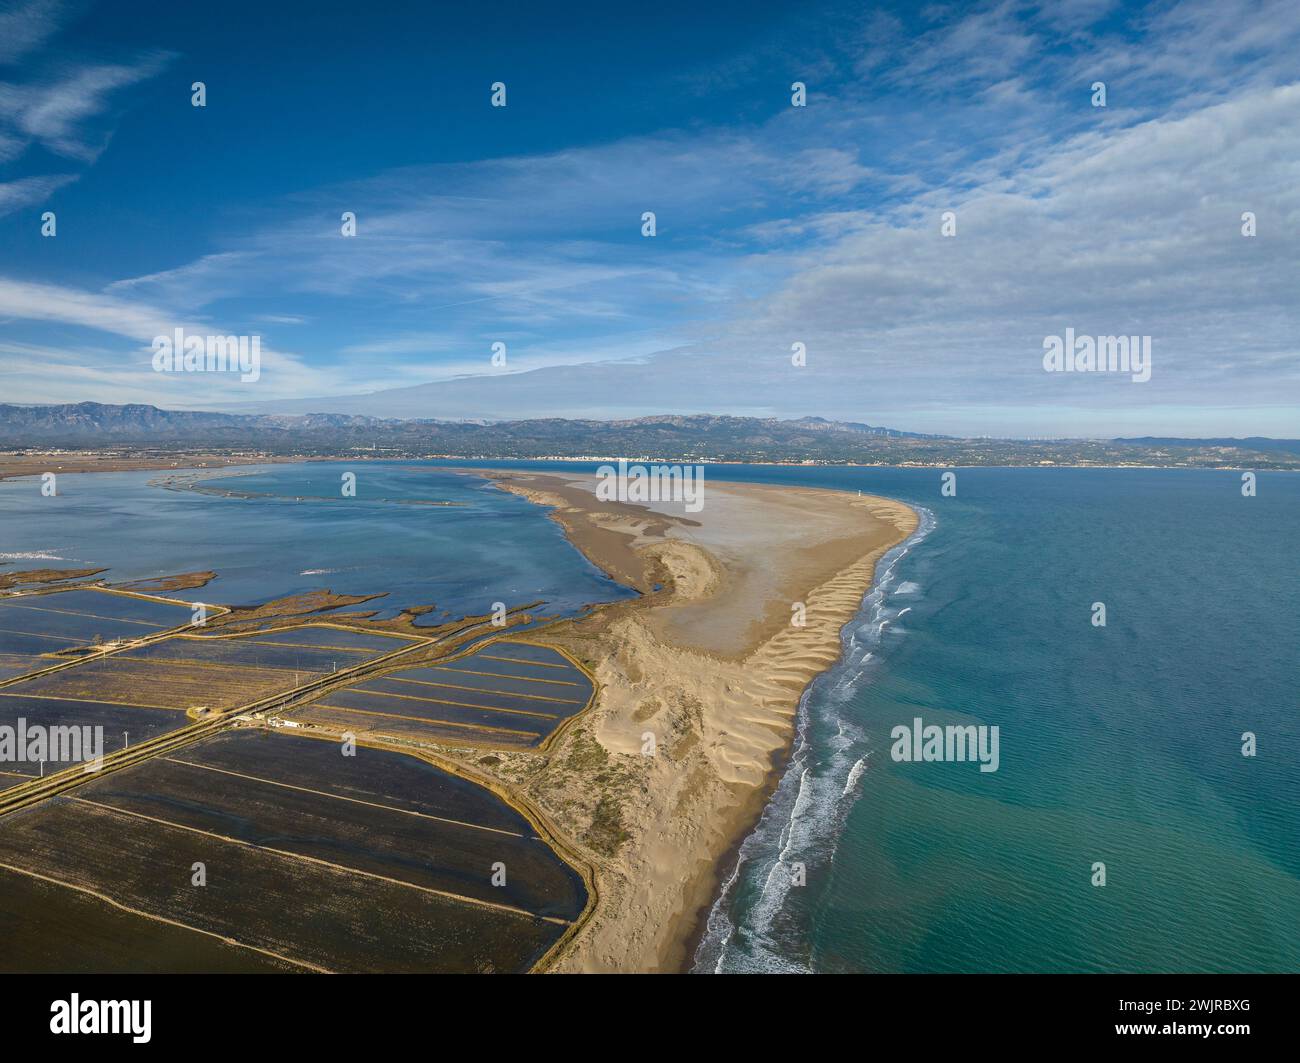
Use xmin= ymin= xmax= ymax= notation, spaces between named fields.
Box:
xmin=241 ymin=73 xmax=1300 ymax=435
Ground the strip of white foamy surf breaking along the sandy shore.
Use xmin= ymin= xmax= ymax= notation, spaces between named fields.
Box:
xmin=694 ymin=508 xmax=935 ymax=973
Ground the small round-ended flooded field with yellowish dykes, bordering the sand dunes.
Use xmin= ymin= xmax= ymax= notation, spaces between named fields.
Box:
xmin=295 ymin=642 xmax=593 ymax=747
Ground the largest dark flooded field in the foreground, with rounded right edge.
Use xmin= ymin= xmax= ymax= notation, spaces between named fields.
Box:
xmin=0 ymin=729 xmax=586 ymax=971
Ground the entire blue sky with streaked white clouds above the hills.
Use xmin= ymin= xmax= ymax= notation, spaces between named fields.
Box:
xmin=0 ymin=0 xmax=1300 ymax=437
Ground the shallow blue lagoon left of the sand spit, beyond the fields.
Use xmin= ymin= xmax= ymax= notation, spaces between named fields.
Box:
xmin=0 ymin=461 xmax=631 ymax=624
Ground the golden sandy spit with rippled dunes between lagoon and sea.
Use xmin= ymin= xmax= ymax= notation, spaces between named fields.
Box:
xmin=473 ymin=470 xmax=918 ymax=972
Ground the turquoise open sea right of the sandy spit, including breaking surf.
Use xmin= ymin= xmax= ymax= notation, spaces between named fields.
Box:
xmin=696 ymin=468 xmax=1300 ymax=972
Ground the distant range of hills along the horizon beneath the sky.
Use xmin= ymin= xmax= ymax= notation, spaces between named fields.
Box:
xmin=0 ymin=403 xmax=1300 ymax=469
